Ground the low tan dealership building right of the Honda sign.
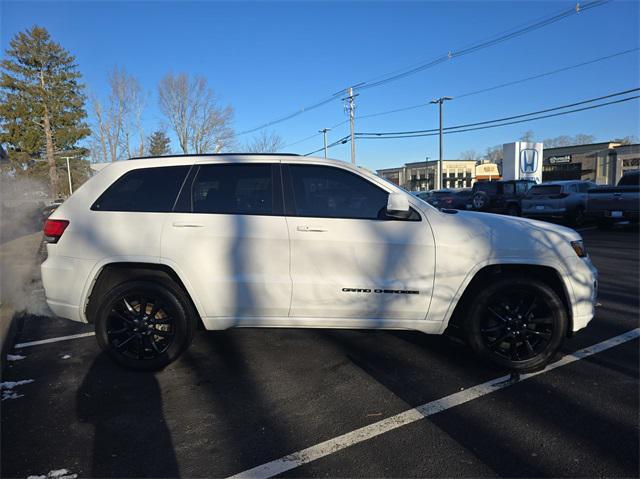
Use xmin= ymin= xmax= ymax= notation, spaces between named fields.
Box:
xmin=542 ymin=142 xmax=640 ymax=185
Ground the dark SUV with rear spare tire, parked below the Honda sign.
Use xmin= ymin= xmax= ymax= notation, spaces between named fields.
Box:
xmin=471 ymin=180 xmax=536 ymax=216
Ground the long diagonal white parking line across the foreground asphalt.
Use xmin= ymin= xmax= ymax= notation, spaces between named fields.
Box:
xmin=231 ymin=328 xmax=640 ymax=478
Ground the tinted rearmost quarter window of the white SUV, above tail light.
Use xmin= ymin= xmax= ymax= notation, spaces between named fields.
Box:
xmin=91 ymin=166 xmax=190 ymax=212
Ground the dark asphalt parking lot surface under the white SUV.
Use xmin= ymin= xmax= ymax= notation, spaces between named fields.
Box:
xmin=1 ymin=228 xmax=640 ymax=477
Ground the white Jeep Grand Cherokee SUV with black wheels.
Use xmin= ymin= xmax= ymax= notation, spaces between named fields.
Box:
xmin=42 ymin=154 xmax=597 ymax=371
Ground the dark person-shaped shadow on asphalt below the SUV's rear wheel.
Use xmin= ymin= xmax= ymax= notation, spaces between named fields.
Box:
xmin=76 ymin=353 xmax=180 ymax=477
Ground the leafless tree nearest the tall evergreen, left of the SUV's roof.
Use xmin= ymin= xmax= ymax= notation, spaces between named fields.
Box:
xmin=92 ymin=67 xmax=145 ymax=162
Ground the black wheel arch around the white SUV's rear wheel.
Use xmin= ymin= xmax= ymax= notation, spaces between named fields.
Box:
xmin=84 ymin=261 xmax=202 ymax=324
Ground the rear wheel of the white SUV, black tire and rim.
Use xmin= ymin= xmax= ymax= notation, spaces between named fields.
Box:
xmin=95 ymin=279 xmax=197 ymax=371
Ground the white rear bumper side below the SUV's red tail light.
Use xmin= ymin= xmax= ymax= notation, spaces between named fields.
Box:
xmin=40 ymin=255 xmax=95 ymax=323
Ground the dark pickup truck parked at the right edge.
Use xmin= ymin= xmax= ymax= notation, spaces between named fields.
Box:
xmin=586 ymin=170 xmax=640 ymax=229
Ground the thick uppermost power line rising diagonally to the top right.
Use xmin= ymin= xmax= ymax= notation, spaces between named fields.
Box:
xmin=236 ymin=0 xmax=610 ymax=136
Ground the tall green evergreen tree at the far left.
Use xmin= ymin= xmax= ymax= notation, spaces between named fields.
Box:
xmin=0 ymin=26 xmax=90 ymax=196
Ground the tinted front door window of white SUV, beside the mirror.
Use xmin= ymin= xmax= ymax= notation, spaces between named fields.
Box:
xmin=289 ymin=165 xmax=388 ymax=219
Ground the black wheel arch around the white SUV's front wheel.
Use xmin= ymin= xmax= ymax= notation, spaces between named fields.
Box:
xmin=445 ymin=264 xmax=573 ymax=336
